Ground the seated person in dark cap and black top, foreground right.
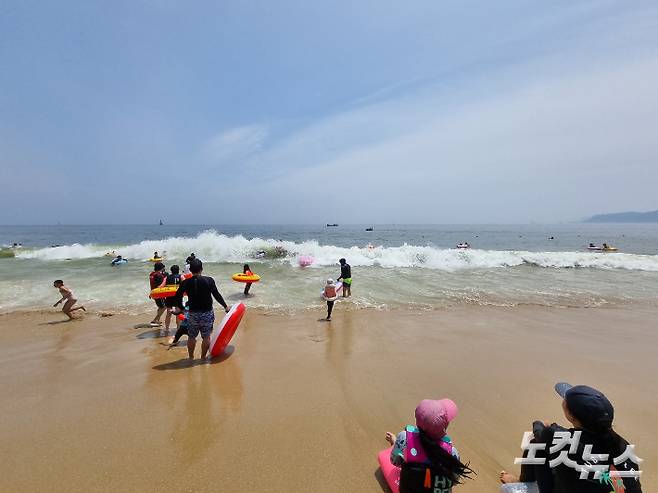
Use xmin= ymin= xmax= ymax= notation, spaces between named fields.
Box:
xmin=500 ymin=382 xmax=642 ymax=493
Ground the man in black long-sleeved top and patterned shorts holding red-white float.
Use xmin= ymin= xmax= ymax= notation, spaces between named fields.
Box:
xmin=176 ymin=259 xmax=229 ymax=359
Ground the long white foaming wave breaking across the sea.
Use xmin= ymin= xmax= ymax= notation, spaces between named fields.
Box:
xmin=16 ymin=231 xmax=658 ymax=272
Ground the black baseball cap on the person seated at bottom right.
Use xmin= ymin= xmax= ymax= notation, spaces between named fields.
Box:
xmin=555 ymin=382 xmax=615 ymax=432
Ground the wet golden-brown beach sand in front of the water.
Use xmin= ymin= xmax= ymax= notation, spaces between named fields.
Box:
xmin=0 ymin=304 xmax=658 ymax=493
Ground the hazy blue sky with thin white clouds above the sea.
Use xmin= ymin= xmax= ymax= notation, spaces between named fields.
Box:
xmin=0 ymin=0 xmax=658 ymax=224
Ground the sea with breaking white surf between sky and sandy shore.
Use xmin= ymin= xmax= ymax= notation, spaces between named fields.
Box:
xmin=0 ymin=224 xmax=658 ymax=313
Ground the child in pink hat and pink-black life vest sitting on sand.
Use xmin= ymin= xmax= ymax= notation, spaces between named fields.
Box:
xmin=379 ymin=399 xmax=474 ymax=493
